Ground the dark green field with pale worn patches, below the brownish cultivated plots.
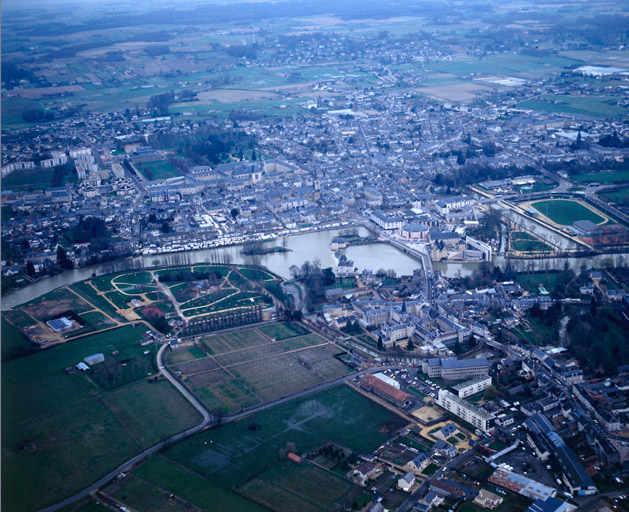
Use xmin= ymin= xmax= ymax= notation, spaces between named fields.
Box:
xmin=165 ymin=386 xmax=406 ymax=489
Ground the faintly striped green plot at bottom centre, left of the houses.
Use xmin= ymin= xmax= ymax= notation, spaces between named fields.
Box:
xmin=238 ymin=461 xmax=353 ymax=512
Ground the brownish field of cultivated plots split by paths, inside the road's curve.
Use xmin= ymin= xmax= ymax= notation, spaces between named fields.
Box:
xmin=168 ymin=323 xmax=351 ymax=414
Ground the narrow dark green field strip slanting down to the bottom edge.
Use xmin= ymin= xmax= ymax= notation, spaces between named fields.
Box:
xmin=133 ymin=456 xmax=265 ymax=512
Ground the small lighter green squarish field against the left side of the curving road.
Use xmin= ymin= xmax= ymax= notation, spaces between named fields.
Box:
xmin=104 ymin=380 xmax=201 ymax=448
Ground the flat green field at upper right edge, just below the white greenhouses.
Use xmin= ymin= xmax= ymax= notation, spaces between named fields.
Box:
xmin=516 ymin=94 xmax=628 ymax=119
